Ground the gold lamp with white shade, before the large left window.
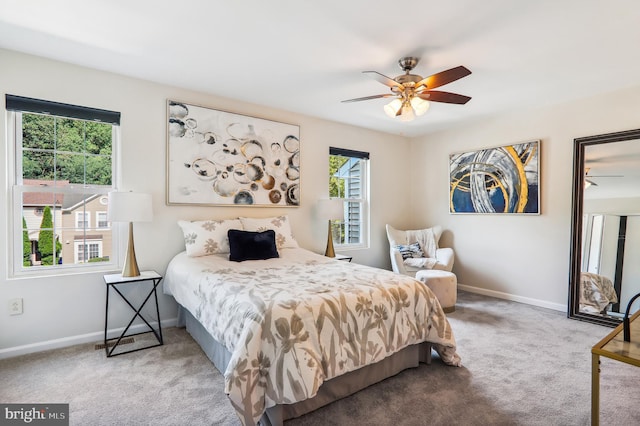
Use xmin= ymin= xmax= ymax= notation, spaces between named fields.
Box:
xmin=107 ymin=192 xmax=153 ymax=277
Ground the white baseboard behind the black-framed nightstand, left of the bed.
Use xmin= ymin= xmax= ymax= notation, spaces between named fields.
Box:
xmin=0 ymin=318 xmax=178 ymax=359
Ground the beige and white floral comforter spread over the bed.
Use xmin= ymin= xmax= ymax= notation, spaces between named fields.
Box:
xmin=164 ymin=249 xmax=460 ymax=424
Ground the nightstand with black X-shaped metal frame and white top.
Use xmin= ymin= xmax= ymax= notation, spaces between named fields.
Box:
xmin=104 ymin=271 xmax=163 ymax=357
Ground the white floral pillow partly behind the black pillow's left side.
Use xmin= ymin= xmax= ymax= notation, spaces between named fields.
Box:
xmin=178 ymin=219 xmax=242 ymax=257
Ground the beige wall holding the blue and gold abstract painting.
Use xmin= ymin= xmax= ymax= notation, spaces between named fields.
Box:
xmin=410 ymin=88 xmax=640 ymax=311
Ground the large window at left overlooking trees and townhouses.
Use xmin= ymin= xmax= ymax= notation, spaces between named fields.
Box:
xmin=6 ymin=95 xmax=120 ymax=275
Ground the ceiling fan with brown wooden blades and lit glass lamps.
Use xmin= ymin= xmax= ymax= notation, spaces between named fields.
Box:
xmin=342 ymin=56 xmax=471 ymax=121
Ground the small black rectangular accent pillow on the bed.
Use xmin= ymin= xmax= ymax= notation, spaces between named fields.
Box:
xmin=227 ymin=229 xmax=280 ymax=262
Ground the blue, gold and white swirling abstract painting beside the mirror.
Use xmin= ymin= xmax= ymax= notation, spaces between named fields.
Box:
xmin=449 ymin=140 xmax=540 ymax=214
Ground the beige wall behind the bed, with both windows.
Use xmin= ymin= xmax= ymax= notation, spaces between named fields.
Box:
xmin=0 ymin=50 xmax=410 ymax=356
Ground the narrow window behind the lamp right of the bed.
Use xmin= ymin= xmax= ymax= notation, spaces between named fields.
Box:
xmin=329 ymin=147 xmax=369 ymax=248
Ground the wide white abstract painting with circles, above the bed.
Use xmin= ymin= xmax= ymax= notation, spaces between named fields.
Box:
xmin=167 ymin=100 xmax=300 ymax=207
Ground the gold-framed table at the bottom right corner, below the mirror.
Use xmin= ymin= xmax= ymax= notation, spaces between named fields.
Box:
xmin=591 ymin=311 xmax=640 ymax=426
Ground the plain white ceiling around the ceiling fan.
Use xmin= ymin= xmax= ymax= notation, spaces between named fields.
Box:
xmin=0 ymin=0 xmax=640 ymax=136
